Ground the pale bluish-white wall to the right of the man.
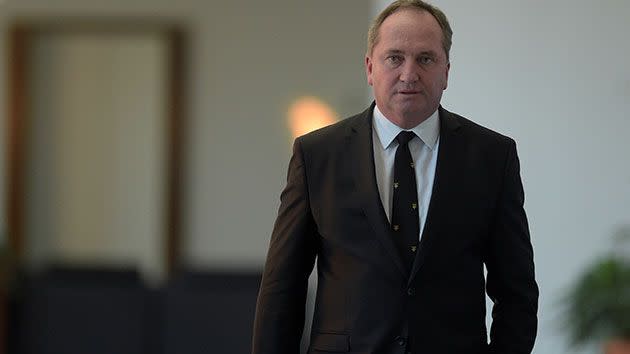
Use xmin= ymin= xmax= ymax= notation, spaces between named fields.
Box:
xmin=374 ymin=0 xmax=630 ymax=354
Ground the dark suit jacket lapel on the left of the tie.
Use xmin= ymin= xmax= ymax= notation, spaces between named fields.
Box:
xmin=347 ymin=104 xmax=409 ymax=279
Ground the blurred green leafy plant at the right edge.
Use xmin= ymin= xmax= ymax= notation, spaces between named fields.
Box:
xmin=565 ymin=228 xmax=630 ymax=354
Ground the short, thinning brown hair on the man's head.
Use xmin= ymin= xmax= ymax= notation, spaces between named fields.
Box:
xmin=367 ymin=0 xmax=453 ymax=60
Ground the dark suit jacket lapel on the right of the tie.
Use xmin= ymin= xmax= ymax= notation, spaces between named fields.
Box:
xmin=409 ymin=106 xmax=465 ymax=284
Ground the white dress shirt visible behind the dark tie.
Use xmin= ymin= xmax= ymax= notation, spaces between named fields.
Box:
xmin=372 ymin=106 xmax=440 ymax=239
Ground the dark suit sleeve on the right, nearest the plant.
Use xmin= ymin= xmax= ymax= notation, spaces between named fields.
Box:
xmin=486 ymin=141 xmax=538 ymax=354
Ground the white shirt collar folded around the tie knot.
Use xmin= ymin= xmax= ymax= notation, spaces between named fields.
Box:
xmin=373 ymin=105 xmax=440 ymax=150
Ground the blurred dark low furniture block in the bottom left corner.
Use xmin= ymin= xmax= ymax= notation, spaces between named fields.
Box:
xmin=16 ymin=267 xmax=147 ymax=354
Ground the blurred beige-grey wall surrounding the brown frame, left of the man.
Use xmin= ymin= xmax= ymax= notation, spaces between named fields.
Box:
xmin=0 ymin=0 xmax=370 ymax=268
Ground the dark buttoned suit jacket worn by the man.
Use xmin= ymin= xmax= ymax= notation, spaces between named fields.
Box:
xmin=252 ymin=104 xmax=538 ymax=354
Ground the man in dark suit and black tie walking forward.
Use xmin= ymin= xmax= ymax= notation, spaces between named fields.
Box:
xmin=253 ymin=0 xmax=538 ymax=354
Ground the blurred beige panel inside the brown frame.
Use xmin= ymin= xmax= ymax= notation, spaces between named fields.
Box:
xmin=25 ymin=32 xmax=168 ymax=280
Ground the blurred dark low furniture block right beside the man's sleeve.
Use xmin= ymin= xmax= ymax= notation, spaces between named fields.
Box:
xmin=163 ymin=272 xmax=261 ymax=354
